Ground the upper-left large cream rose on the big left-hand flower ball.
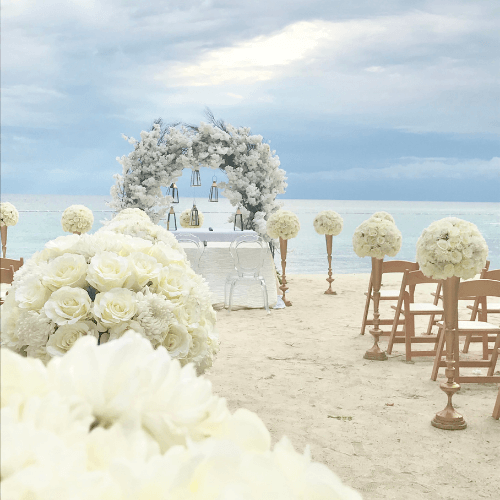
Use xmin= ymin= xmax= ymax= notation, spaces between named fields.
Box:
xmin=42 ymin=253 xmax=87 ymax=291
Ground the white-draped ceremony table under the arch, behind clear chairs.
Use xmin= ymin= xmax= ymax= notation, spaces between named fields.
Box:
xmin=181 ymin=239 xmax=278 ymax=308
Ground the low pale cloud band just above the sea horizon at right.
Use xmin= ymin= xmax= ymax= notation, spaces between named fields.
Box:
xmin=290 ymin=157 xmax=500 ymax=185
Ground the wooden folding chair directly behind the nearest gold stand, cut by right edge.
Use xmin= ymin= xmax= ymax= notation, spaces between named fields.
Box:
xmin=431 ymin=279 xmax=500 ymax=384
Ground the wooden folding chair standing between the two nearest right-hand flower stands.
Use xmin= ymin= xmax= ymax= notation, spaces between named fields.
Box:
xmin=387 ymin=271 xmax=444 ymax=361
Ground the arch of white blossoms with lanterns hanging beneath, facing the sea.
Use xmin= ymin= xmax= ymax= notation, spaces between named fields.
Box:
xmin=110 ymin=120 xmax=287 ymax=239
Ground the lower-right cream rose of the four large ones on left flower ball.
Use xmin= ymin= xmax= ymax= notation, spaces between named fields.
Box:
xmin=94 ymin=288 xmax=137 ymax=327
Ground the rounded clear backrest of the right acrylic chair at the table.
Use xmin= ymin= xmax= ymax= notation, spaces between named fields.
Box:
xmin=229 ymin=234 xmax=269 ymax=277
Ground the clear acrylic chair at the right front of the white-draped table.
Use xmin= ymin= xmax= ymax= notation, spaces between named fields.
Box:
xmin=224 ymin=235 xmax=269 ymax=313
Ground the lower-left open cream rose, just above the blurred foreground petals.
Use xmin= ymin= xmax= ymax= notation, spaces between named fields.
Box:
xmin=43 ymin=286 xmax=92 ymax=325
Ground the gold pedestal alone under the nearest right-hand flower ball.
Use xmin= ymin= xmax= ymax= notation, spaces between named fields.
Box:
xmin=431 ymin=276 xmax=467 ymax=431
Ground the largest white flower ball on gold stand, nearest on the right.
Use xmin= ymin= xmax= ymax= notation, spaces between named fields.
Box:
xmin=417 ymin=217 xmax=488 ymax=430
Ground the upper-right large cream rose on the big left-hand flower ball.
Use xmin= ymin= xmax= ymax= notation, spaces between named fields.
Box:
xmin=87 ymin=252 xmax=132 ymax=292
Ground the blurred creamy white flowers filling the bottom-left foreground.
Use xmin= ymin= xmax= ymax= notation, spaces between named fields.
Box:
xmin=1 ymin=332 xmax=361 ymax=500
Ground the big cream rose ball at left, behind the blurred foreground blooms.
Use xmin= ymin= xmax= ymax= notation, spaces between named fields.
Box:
xmin=1 ymin=229 xmax=218 ymax=373
